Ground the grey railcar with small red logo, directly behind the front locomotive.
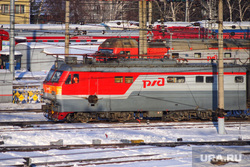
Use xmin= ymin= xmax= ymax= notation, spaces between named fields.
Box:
xmin=167 ymin=39 xmax=250 ymax=65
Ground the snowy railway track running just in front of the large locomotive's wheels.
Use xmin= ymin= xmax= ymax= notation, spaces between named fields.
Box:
xmin=0 ymin=121 xmax=250 ymax=132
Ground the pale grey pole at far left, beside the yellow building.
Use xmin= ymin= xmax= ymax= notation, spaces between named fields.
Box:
xmin=9 ymin=0 xmax=15 ymax=80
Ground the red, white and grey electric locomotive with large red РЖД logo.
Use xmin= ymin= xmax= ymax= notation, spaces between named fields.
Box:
xmin=43 ymin=56 xmax=250 ymax=122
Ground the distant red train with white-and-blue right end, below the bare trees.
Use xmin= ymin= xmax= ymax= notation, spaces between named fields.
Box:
xmin=151 ymin=21 xmax=250 ymax=40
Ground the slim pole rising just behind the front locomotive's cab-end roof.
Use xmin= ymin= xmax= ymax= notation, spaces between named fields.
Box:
xmin=64 ymin=0 xmax=70 ymax=61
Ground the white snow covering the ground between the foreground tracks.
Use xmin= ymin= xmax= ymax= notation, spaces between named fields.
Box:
xmin=0 ymin=104 xmax=250 ymax=167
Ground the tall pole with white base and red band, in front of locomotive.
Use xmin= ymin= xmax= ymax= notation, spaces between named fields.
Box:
xmin=218 ymin=0 xmax=225 ymax=134
